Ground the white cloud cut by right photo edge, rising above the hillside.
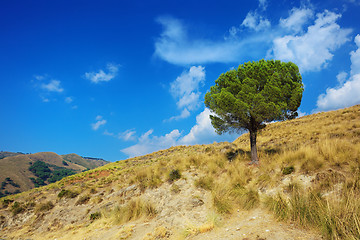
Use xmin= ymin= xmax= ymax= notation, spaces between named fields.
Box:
xmin=316 ymin=34 xmax=360 ymax=111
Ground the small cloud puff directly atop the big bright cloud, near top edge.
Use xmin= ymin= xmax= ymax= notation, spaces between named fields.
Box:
xmin=279 ymin=8 xmax=314 ymax=33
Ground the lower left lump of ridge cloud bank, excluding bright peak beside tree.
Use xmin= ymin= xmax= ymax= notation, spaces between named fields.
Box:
xmin=121 ymin=129 xmax=181 ymax=157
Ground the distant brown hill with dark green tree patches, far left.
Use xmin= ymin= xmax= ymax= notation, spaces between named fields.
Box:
xmin=0 ymin=152 xmax=109 ymax=197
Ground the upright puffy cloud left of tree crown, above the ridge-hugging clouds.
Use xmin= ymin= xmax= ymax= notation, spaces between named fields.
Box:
xmin=170 ymin=66 xmax=205 ymax=120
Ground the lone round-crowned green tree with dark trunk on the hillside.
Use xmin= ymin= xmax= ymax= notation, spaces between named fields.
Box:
xmin=205 ymin=60 xmax=304 ymax=163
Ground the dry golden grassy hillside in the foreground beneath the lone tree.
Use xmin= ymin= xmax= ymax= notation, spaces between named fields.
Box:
xmin=0 ymin=105 xmax=360 ymax=240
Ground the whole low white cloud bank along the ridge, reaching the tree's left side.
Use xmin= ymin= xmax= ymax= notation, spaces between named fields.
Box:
xmin=121 ymin=108 xmax=238 ymax=157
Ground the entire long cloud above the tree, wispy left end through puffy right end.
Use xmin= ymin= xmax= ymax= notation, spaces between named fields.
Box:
xmin=155 ymin=7 xmax=352 ymax=72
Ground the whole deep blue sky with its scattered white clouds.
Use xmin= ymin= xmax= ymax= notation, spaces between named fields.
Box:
xmin=0 ymin=0 xmax=360 ymax=161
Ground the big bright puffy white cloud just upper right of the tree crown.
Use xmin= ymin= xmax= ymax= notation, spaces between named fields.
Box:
xmin=272 ymin=10 xmax=351 ymax=71
